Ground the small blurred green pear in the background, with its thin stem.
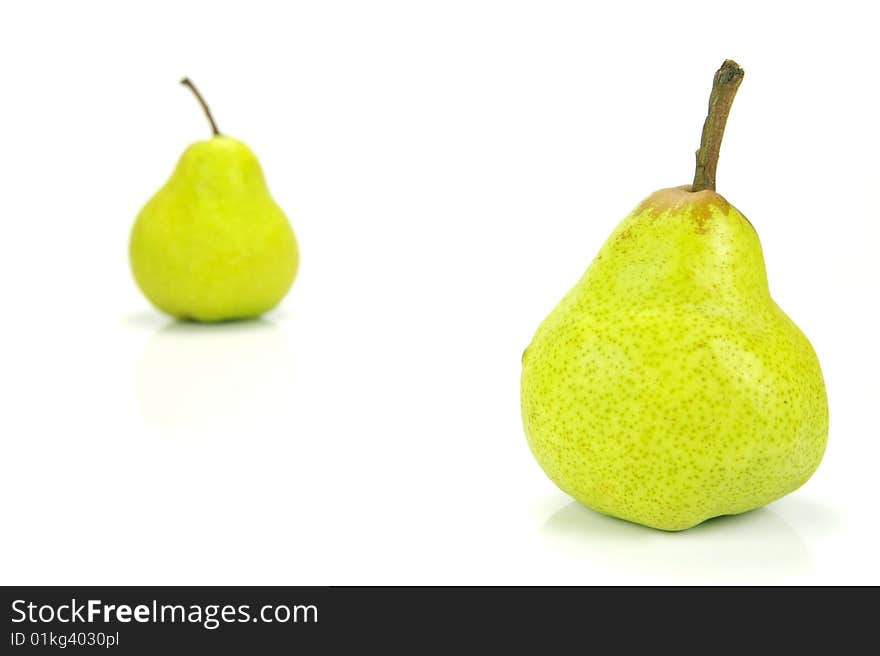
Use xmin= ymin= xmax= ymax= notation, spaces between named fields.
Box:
xmin=129 ymin=79 xmax=299 ymax=321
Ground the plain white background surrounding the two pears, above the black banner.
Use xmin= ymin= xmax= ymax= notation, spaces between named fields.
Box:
xmin=0 ymin=0 xmax=880 ymax=584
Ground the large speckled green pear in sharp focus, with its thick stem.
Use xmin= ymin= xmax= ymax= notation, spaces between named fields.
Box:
xmin=521 ymin=61 xmax=828 ymax=531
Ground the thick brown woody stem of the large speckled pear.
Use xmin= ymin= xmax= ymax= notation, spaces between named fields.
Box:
xmin=691 ymin=59 xmax=745 ymax=191
